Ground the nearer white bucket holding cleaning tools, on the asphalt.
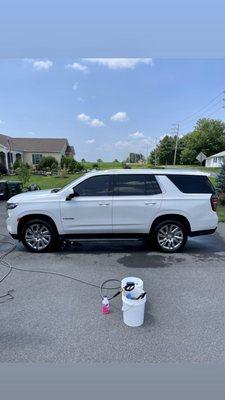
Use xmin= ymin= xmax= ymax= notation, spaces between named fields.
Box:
xmin=122 ymin=290 xmax=146 ymax=326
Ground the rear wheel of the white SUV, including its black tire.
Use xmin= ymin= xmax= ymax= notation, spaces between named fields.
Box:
xmin=150 ymin=219 xmax=188 ymax=253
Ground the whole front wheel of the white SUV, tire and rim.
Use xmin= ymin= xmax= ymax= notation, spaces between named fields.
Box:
xmin=21 ymin=219 xmax=59 ymax=253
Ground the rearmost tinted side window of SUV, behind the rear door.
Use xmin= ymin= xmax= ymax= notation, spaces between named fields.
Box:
xmin=167 ymin=175 xmax=215 ymax=193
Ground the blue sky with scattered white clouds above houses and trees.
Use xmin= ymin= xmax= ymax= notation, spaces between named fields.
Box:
xmin=0 ymin=58 xmax=225 ymax=161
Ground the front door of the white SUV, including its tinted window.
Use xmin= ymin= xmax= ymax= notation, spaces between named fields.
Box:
xmin=61 ymin=175 xmax=112 ymax=234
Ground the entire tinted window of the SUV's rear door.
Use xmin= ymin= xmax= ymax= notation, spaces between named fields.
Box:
xmin=114 ymin=174 xmax=161 ymax=196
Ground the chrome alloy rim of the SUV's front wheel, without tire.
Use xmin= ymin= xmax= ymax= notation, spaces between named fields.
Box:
xmin=25 ymin=223 xmax=51 ymax=250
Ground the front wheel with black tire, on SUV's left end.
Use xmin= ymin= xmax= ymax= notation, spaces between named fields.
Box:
xmin=21 ymin=219 xmax=59 ymax=253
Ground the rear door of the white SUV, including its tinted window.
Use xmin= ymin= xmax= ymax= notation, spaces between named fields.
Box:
xmin=113 ymin=173 xmax=162 ymax=233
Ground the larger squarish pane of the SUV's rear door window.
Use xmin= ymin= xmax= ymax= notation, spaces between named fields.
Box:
xmin=115 ymin=174 xmax=145 ymax=196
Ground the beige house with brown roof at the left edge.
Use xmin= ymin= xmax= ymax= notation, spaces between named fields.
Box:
xmin=0 ymin=134 xmax=75 ymax=170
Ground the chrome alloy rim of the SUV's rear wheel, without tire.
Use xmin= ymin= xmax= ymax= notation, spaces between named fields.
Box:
xmin=157 ymin=224 xmax=184 ymax=250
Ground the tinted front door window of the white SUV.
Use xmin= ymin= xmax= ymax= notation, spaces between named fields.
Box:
xmin=74 ymin=175 xmax=110 ymax=196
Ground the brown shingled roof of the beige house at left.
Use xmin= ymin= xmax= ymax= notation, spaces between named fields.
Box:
xmin=0 ymin=134 xmax=72 ymax=153
